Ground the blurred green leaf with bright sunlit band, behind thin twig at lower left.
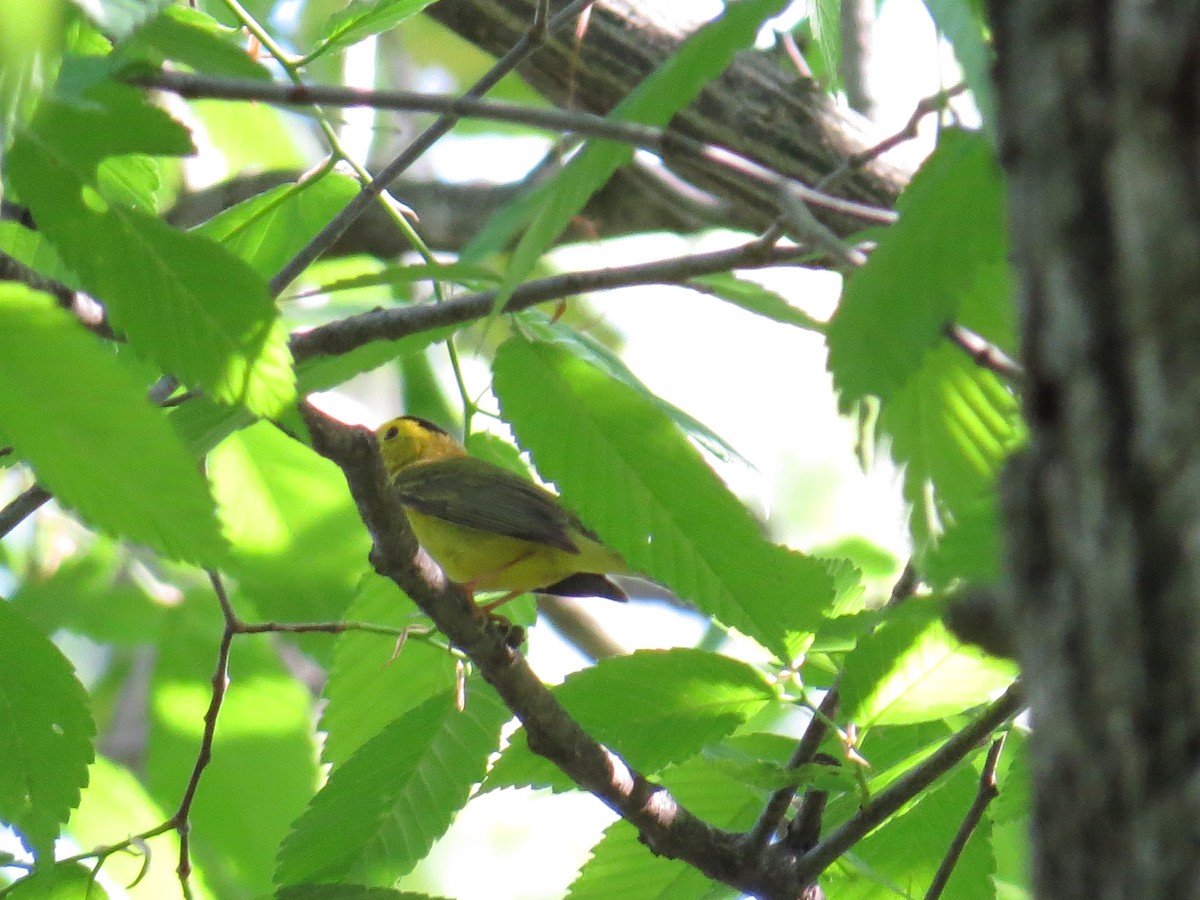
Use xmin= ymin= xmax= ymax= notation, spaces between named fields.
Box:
xmin=144 ymin=602 xmax=318 ymax=898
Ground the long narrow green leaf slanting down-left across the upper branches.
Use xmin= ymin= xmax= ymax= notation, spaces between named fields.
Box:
xmin=463 ymin=0 xmax=787 ymax=294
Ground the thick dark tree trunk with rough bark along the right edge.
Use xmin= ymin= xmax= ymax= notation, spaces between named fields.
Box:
xmin=992 ymin=0 xmax=1200 ymax=900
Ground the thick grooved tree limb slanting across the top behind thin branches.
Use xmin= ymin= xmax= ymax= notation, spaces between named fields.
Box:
xmin=426 ymin=0 xmax=906 ymax=235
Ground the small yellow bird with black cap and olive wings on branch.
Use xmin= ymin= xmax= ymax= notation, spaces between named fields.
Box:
xmin=376 ymin=415 xmax=629 ymax=611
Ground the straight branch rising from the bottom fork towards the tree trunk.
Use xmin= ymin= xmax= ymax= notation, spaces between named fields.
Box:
xmin=798 ymin=682 xmax=1025 ymax=883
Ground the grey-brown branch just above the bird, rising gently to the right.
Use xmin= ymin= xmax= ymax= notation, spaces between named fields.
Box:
xmin=290 ymin=240 xmax=811 ymax=362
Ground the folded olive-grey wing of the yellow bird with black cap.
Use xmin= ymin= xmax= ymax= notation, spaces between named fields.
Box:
xmin=392 ymin=457 xmax=582 ymax=553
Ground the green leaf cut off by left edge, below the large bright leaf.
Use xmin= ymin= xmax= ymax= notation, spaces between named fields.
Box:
xmin=0 ymin=601 xmax=96 ymax=854
